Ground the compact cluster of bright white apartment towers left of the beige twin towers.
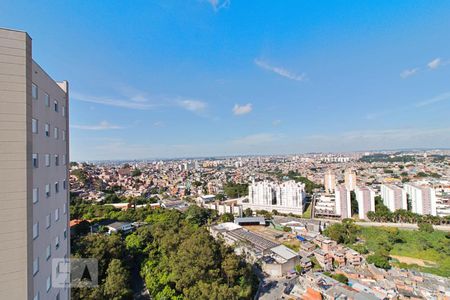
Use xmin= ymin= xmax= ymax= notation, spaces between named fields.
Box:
xmin=243 ymin=180 xmax=306 ymax=214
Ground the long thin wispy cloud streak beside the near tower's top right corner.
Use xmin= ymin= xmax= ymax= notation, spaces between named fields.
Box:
xmin=70 ymin=92 xmax=156 ymax=110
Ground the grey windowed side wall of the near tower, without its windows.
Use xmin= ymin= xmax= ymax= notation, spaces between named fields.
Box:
xmin=31 ymin=61 xmax=70 ymax=299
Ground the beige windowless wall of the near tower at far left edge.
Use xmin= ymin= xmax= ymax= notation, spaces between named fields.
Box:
xmin=0 ymin=30 xmax=33 ymax=299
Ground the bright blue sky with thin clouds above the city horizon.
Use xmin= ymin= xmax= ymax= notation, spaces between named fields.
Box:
xmin=0 ymin=0 xmax=450 ymax=160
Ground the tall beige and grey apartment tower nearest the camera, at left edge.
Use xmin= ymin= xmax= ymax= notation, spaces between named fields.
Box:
xmin=0 ymin=29 xmax=70 ymax=300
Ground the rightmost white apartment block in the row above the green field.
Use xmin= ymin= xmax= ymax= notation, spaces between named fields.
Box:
xmin=404 ymin=184 xmax=437 ymax=216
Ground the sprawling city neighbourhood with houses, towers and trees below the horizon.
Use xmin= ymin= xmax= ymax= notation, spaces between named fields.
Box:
xmin=70 ymin=150 xmax=450 ymax=299
